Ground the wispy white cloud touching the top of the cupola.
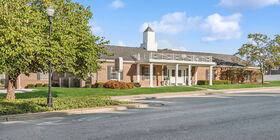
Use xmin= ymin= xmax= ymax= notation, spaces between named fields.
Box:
xmin=140 ymin=12 xmax=201 ymax=34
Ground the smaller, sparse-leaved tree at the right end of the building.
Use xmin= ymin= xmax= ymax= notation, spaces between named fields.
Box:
xmin=236 ymin=34 xmax=280 ymax=84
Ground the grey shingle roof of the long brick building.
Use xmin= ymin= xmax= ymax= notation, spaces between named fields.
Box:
xmin=101 ymin=45 xmax=246 ymax=66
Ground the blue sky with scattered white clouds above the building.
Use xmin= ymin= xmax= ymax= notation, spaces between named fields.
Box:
xmin=73 ymin=0 xmax=280 ymax=54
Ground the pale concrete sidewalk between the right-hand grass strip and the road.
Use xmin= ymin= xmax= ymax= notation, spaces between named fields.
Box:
xmin=111 ymin=87 xmax=280 ymax=102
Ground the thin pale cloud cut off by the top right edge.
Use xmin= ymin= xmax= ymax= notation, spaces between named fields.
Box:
xmin=219 ymin=0 xmax=280 ymax=10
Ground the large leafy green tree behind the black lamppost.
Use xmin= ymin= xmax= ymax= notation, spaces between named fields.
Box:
xmin=0 ymin=0 xmax=108 ymax=99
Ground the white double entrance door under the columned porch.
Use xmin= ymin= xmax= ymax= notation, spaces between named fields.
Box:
xmin=169 ymin=69 xmax=186 ymax=85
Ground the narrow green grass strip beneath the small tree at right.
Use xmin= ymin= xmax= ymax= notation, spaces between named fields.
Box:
xmin=195 ymin=81 xmax=280 ymax=90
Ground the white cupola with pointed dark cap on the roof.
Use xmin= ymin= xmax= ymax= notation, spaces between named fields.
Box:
xmin=141 ymin=26 xmax=157 ymax=51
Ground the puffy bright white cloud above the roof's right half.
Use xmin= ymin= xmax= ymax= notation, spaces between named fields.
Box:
xmin=201 ymin=14 xmax=242 ymax=42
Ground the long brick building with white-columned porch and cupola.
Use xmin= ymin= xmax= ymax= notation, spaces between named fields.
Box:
xmin=4 ymin=27 xmax=257 ymax=88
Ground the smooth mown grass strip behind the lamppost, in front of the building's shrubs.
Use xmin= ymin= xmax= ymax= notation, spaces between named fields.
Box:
xmin=0 ymin=86 xmax=201 ymax=99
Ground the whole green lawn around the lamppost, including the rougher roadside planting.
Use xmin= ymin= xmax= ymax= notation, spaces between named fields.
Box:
xmin=0 ymin=86 xmax=201 ymax=116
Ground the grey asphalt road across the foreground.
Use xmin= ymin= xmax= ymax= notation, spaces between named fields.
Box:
xmin=0 ymin=91 xmax=280 ymax=140
